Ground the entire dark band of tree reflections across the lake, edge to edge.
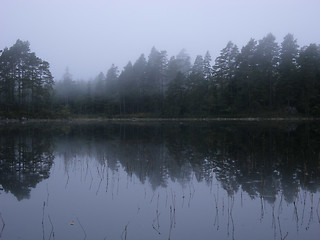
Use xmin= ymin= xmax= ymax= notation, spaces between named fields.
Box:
xmin=0 ymin=122 xmax=320 ymax=203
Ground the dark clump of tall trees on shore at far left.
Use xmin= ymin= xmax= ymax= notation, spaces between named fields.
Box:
xmin=0 ymin=40 xmax=53 ymax=117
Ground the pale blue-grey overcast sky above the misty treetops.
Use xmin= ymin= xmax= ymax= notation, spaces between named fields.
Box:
xmin=0 ymin=0 xmax=320 ymax=79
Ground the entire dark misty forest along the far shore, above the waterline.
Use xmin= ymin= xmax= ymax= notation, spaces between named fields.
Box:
xmin=0 ymin=33 xmax=320 ymax=118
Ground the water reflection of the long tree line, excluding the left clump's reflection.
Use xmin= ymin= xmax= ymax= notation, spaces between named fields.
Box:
xmin=53 ymin=122 xmax=320 ymax=202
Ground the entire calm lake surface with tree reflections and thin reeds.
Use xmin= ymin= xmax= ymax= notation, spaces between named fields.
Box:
xmin=0 ymin=122 xmax=320 ymax=240
